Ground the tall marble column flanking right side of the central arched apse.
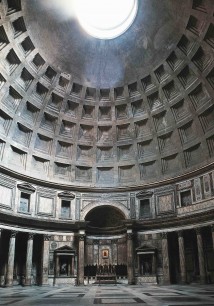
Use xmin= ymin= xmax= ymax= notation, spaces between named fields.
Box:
xmin=127 ymin=230 xmax=135 ymax=285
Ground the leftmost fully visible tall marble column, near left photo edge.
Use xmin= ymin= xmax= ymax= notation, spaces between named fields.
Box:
xmin=5 ymin=231 xmax=17 ymax=287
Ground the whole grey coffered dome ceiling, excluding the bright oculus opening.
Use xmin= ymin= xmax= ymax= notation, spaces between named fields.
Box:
xmin=0 ymin=0 xmax=214 ymax=188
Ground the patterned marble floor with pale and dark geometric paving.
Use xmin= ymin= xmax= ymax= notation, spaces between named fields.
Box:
xmin=0 ymin=285 xmax=214 ymax=306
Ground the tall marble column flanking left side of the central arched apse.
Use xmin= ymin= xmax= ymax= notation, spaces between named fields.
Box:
xmin=78 ymin=231 xmax=85 ymax=286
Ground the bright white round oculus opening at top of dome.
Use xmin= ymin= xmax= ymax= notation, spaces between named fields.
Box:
xmin=74 ymin=0 xmax=138 ymax=39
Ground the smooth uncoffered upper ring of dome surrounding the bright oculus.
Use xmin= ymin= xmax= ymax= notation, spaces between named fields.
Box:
xmin=22 ymin=0 xmax=191 ymax=88
